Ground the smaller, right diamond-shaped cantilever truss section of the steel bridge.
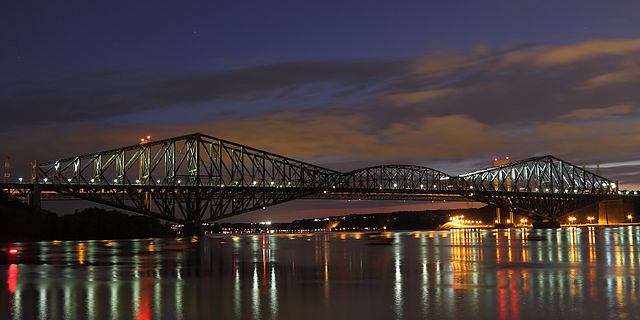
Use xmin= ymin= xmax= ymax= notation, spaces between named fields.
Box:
xmin=458 ymin=156 xmax=617 ymax=220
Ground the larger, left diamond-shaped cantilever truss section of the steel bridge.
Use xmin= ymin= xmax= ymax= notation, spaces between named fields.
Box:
xmin=37 ymin=133 xmax=341 ymax=222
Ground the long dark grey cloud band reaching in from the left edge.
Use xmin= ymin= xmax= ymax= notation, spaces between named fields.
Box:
xmin=0 ymin=61 xmax=407 ymax=128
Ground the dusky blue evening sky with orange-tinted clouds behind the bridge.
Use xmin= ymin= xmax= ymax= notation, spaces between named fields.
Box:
xmin=0 ymin=0 xmax=640 ymax=221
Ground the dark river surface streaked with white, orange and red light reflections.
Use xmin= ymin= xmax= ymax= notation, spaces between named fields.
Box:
xmin=0 ymin=227 xmax=640 ymax=319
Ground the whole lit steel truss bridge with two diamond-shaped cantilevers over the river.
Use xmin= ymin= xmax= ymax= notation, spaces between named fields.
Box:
xmin=2 ymin=133 xmax=618 ymax=224
